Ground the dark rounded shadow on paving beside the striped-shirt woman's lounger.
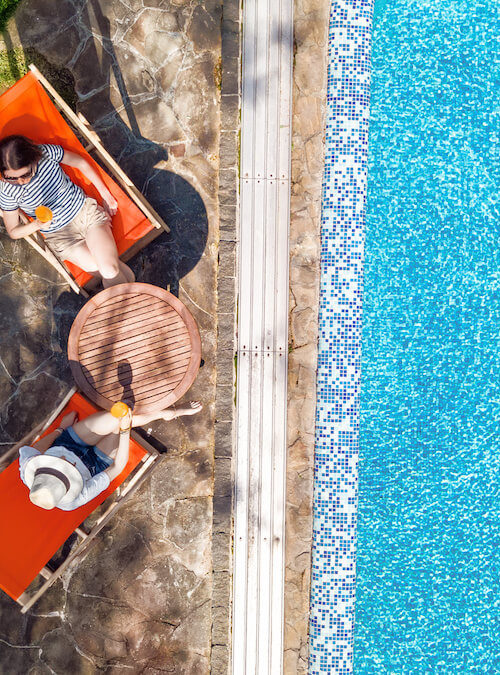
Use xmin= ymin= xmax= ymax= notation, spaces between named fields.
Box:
xmin=16 ymin=0 xmax=208 ymax=295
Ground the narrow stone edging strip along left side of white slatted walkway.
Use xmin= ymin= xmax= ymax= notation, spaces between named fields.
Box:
xmin=210 ymin=0 xmax=241 ymax=675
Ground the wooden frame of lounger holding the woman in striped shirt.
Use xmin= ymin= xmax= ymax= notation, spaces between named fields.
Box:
xmin=20 ymin=64 xmax=170 ymax=297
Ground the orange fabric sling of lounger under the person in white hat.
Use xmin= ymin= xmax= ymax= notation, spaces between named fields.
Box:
xmin=0 ymin=393 xmax=147 ymax=600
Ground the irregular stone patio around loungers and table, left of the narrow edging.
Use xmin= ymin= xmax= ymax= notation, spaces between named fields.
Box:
xmin=0 ymin=0 xmax=225 ymax=674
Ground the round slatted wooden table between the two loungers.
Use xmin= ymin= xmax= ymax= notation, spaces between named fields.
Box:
xmin=68 ymin=283 xmax=201 ymax=413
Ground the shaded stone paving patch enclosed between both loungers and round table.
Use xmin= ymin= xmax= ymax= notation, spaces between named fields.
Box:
xmin=0 ymin=233 xmax=75 ymax=446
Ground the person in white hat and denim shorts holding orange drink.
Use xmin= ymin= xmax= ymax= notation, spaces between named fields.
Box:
xmin=19 ymin=401 xmax=202 ymax=511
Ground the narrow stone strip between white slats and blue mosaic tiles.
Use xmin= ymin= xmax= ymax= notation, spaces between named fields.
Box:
xmin=284 ymin=0 xmax=330 ymax=675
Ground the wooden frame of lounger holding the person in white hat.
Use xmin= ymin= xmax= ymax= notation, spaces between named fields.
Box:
xmin=0 ymin=387 xmax=160 ymax=614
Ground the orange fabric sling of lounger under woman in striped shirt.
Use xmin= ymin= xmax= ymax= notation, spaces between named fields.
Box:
xmin=0 ymin=72 xmax=153 ymax=286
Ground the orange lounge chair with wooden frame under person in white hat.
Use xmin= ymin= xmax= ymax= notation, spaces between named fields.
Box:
xmin=0 ymin=389 xmax=159 ymax=613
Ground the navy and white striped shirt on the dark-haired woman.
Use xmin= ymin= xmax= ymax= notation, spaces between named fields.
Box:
xmin=0 ymin=145 xmax=85 ymax=234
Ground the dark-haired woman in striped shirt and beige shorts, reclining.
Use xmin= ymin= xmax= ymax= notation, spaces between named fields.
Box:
xmin=0 ymin=136 xmax=135 ymax=288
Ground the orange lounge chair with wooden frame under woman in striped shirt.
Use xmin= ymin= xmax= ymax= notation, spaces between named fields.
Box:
xmin=0 ymin=65 xmax=170 ymax=295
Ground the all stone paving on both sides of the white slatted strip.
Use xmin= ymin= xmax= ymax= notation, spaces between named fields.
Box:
xmin=0 ymin=0 xmax=330 ymax=675
